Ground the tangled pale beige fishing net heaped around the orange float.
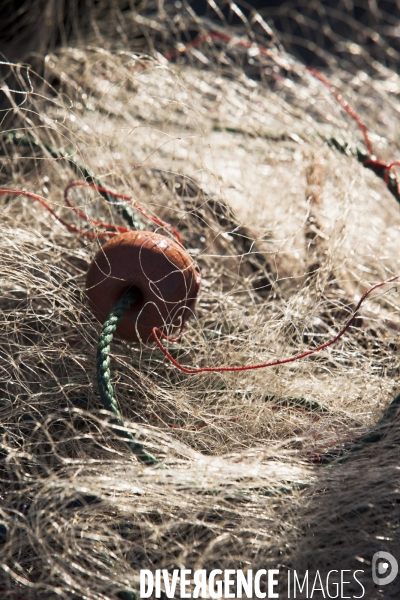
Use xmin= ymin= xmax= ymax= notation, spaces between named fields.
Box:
xmin=0 ymin=0 xmax=400 ymax=600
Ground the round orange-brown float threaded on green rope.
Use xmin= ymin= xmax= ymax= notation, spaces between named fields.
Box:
xmin=86 ymin=231 xmax=201 ymax=342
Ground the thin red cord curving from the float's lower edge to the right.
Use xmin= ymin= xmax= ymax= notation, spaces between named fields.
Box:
xmin=153 ymin=275 xmax=400 ymax=375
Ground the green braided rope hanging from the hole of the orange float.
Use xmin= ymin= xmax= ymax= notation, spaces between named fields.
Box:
xmin=96 ymin=291 xmax=159 ymax=465
